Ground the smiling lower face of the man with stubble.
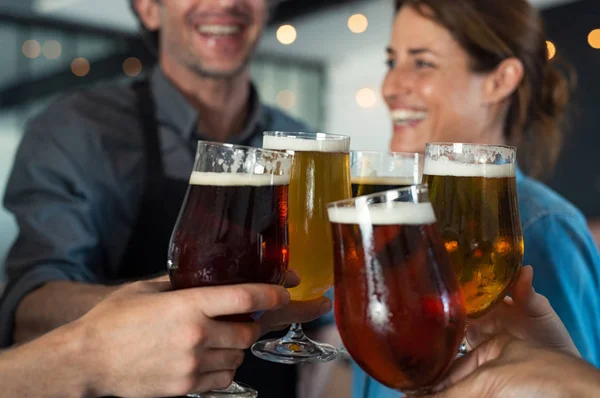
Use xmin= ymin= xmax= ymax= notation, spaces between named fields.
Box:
xmin=152 ymin=0 xmax=267 ymax=79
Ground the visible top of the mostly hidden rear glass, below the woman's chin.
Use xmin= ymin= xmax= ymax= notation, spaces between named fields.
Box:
xmin=350 ymin=151 xmax=423 ymax=197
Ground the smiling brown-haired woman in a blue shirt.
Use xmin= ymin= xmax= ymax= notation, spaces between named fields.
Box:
xmin=354 ymin=0 xmax=600 ymax=398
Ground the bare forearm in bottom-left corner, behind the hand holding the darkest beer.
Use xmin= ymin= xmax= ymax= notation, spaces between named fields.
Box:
xmin=0 ymin=325 xmax=97 ymax=398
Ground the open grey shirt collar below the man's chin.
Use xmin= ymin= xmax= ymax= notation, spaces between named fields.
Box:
xmin=150 ymin=66 xmax=267 ymax=144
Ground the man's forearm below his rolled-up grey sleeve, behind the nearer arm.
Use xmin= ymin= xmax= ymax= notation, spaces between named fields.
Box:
xmin=13 ymin=282 xmax=117 ymax=344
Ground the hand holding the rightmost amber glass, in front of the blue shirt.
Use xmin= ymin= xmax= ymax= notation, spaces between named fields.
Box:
xmin=467 ymin=265 xmax=581 ymax=357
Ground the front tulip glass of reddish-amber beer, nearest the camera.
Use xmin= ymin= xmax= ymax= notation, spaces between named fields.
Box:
xmin=329 ymin=185 xmax=466 ymax=395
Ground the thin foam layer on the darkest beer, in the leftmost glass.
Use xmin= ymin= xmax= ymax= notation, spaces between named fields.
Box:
xmin=190 ymin=171 xmax=290 ymax=187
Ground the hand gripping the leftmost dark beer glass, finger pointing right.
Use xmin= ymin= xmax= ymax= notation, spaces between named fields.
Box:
xmin=73 ymin=277 xmax=290 ymax=397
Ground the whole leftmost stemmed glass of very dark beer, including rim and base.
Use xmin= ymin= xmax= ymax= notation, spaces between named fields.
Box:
xmin=168 ymin=141 xmax=292 ymax=398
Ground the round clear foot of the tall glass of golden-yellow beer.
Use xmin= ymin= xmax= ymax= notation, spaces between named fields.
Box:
xmin=252 ymin=336 xmax=338 ymax=365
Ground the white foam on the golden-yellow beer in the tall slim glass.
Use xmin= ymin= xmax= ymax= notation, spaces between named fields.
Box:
xmin=263 ymin=134 xmax=350 ymax=153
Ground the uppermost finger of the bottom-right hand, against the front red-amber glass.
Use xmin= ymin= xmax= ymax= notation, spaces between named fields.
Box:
xmin=434 ymin=335 xmax=514 ymax=391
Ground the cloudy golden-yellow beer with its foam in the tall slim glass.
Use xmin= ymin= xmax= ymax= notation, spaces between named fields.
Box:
xmin=263 ymin=133 xmax=351 ymax=300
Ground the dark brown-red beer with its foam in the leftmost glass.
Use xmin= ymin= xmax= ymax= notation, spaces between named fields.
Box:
xmin=169 ymin=171 xmax=289 ymax=289
